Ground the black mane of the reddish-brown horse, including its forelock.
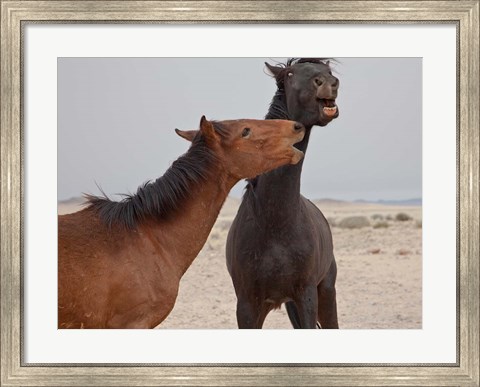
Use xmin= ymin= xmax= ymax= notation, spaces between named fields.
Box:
xmin=84 ymin=122 xmax=225 ymax=229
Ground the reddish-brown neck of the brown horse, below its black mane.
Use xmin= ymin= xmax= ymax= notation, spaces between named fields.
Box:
xmin=146 ymin=163 xmax=237 ymax=276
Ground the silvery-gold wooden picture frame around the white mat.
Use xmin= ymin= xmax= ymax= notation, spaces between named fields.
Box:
xmin=1 ymin=0 xmax=480 ymax=386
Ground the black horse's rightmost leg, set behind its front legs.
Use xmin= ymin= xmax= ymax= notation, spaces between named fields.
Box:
xmin=317 ymin=261 xmax=338 ymax=329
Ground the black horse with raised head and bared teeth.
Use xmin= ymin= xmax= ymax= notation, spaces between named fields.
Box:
xmin=226 ymin=58 xmax=339 ymax=328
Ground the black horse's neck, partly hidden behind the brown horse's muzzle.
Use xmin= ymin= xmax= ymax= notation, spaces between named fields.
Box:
xmin=249 ymin=91 xmax=312 ymax=223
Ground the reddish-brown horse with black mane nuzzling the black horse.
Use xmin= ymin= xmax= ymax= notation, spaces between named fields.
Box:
xmin=58 ymin=117 xmax=305 ymax=329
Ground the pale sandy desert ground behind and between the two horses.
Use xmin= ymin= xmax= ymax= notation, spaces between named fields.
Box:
xmin=59 ymin=198 xmax=422 ymax=329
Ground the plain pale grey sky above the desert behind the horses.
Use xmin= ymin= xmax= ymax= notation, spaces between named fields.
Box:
xmin=57 ymin=58 xmax=422 ymax=200
